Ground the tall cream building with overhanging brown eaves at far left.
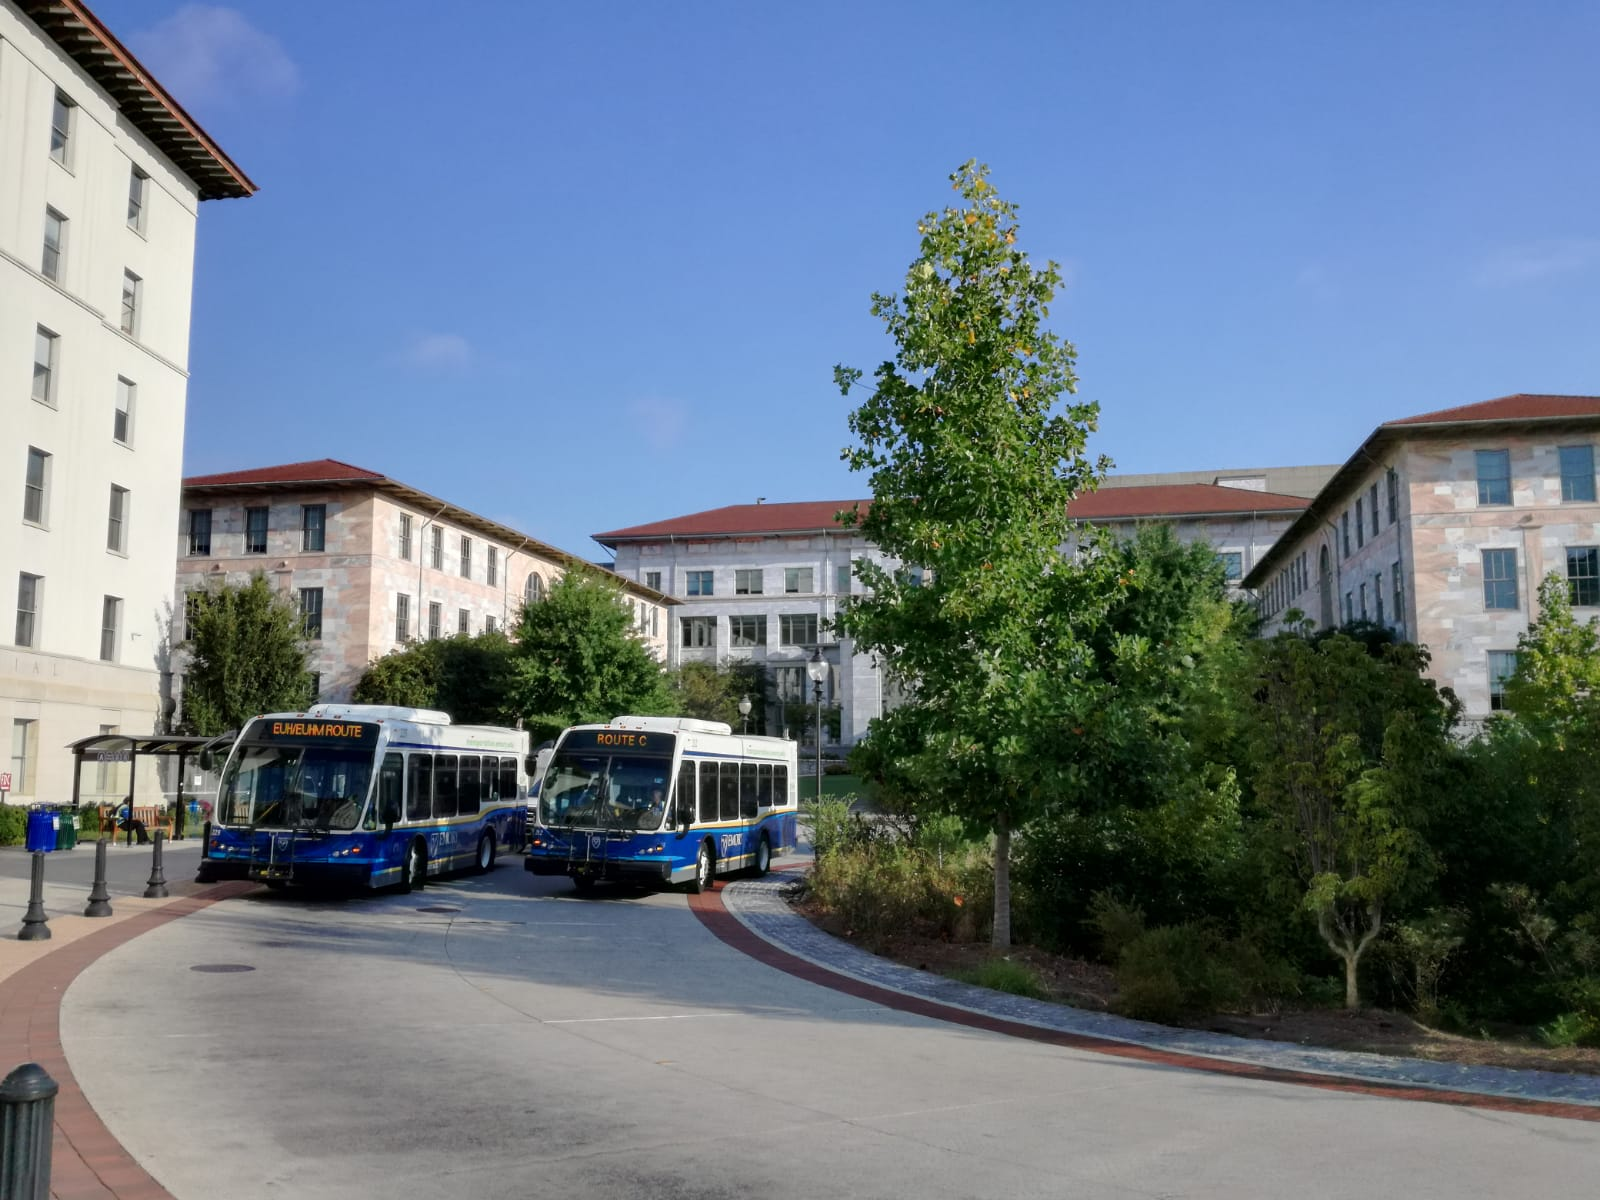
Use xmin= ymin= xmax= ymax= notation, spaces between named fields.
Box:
xmin=0 ymin=0 xmax=256 ymax=802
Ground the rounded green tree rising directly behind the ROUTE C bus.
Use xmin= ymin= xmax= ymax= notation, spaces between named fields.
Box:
xmin=507 ymin=566 xmax=670 ymax=741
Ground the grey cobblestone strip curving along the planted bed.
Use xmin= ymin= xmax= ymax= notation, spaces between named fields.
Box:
xmin=718 ymin=874 xmax=1600 ymax=1118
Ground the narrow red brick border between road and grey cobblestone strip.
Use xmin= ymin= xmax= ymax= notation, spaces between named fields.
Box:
xmin=690 ymin=882 xmax=1600 ymax=1122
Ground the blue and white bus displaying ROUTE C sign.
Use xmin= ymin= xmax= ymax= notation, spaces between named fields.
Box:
xmin=523 ymin=717 xmax=800 ymax=891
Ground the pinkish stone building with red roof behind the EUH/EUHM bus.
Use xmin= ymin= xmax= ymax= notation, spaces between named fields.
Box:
xmin=168 ymin=459 xmax=672 ymax=701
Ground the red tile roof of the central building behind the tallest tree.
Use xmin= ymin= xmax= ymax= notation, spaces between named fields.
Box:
xmin=594 ymin=483 xmax=1309 ymax=546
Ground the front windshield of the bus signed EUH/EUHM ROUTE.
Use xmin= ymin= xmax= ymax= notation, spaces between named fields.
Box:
xmin=218 ymin=742 xmax=373 ymax=829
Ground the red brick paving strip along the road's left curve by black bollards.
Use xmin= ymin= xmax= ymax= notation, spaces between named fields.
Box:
xmin=0 ymin=883 xmax=254 ymax=1200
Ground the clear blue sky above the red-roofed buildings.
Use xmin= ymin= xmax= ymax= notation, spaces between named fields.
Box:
xmin=109 ymin=0 xmax=1600 ymax=557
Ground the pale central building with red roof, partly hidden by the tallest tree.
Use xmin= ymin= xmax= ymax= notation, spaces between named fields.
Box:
xmin=595 ymin=467 xmax=1322 ymax=746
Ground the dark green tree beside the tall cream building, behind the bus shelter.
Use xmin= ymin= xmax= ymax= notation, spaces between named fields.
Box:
xmin=181 ymin=571 xmax=315 ymax=734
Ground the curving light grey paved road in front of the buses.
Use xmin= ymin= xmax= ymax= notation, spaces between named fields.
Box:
xmin=61 ymin=862 xmax=1600 ymax=1200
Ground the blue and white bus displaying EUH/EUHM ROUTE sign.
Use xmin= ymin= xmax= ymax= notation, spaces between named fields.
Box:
xmin=198 ymin=704 xmax=528 ymax=891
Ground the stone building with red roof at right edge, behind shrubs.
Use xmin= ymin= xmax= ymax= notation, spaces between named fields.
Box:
xmin=1245 ymin=395 xmax=1600 ymax=718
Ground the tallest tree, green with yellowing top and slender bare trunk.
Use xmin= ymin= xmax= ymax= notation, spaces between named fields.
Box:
xmin=834 ymin=162 xmax=1112 ymax=946
